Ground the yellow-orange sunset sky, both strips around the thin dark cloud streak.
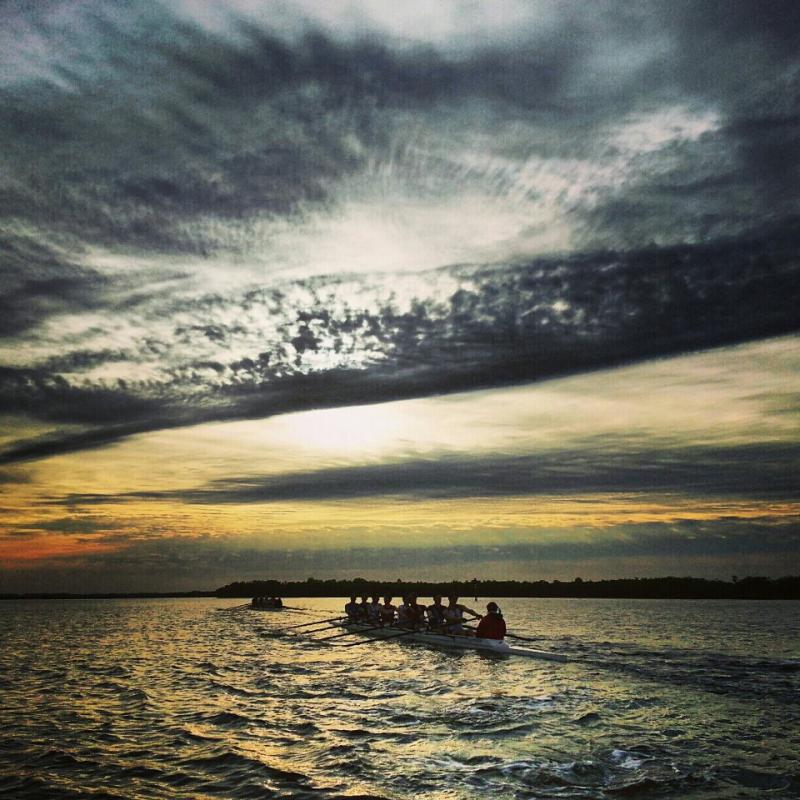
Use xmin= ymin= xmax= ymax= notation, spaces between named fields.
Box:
xmin=0 ymin=337 xmax=800 ymax=580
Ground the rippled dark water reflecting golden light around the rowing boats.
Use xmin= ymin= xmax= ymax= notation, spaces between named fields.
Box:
xmin=0 ymin=599 xmax=800 ymax=800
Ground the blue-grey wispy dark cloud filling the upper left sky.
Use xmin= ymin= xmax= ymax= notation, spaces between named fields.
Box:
xmin=0 ymin=4 xmax=580 ymax=253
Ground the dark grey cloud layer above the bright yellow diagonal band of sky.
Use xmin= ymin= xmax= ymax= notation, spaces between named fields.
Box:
xmin=0 ymin=2 xmax=800 ymax=463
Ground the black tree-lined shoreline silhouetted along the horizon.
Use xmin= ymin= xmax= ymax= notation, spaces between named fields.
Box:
xmin=0 ymin=575 xmax=800 ymax=600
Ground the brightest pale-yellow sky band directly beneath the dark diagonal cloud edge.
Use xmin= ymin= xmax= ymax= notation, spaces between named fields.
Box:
xmin=10 ymin=338 xmax=800 ymax=494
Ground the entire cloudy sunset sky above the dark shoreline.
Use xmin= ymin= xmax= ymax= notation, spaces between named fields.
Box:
xmin=0 ymin=0 xmax=800 ymax=592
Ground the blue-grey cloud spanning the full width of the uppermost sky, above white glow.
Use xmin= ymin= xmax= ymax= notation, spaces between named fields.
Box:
xmin=0 ymin=3 xmax=800 ymax=252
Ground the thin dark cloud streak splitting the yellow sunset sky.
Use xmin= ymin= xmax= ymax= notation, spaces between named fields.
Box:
xmin=53 ymin=437 xmax=800 ymax=506
